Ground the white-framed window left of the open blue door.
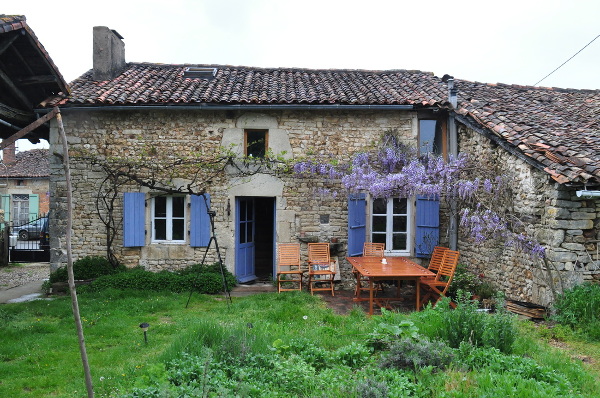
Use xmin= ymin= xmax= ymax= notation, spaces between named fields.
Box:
xmin=152 ymin=196 xmax=186 ymax=243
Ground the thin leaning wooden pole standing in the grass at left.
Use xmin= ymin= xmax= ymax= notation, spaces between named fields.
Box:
xmin=53 ymin=107 xmax=94 ymax=398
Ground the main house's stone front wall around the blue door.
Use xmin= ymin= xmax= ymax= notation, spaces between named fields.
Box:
xmin=50 ymin=109 xmax=417 ymax=280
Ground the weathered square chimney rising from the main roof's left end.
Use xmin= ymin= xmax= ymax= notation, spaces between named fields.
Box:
xmin=93 ymin=26 xmax=126 ymax=81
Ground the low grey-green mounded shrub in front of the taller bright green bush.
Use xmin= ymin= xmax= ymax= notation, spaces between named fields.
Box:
xmin=380 ymin=337 xmax=454 ymax=370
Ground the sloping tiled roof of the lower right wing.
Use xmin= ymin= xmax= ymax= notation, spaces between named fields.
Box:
xmin=456 ymin=80 xmax=600 ymax=184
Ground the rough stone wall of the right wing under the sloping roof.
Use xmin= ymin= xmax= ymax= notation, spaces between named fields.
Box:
xmin=459 ymin=127 xmax=600 ymax=305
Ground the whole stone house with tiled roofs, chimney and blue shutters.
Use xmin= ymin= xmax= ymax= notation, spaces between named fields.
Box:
xmin=43 ymin=27 xmax=600 ymax=303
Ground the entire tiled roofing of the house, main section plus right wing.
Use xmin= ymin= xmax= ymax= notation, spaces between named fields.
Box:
xmin=54 ymin=63 xmax=600 ymax=184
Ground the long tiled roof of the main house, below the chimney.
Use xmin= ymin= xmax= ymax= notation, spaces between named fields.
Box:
xmin=56 ymin=63 xmax=447 ymax=106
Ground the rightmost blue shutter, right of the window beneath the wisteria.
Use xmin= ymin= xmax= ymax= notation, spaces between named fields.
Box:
xmin=415 ymin=196 xmax=440 ymax=257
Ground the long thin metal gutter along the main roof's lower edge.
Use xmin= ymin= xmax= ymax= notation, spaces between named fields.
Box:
xmin=36 ymin=104 xmax=418 ymax=113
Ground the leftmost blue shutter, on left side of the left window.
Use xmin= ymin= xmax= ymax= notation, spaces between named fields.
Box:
xmin=123 ymin=192 xmax=146 ymax=247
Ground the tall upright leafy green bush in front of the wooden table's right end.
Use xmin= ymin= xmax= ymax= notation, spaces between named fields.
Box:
xmin=430 ymin=292 xmax=517 ymax=353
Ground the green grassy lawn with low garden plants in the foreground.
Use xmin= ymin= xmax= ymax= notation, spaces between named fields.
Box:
xmin=0 ymin=289 xmax=600 ymax=398
